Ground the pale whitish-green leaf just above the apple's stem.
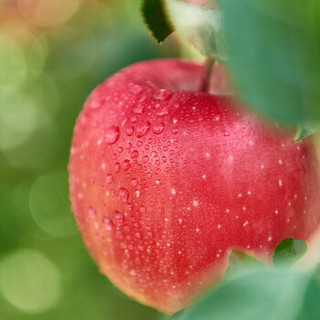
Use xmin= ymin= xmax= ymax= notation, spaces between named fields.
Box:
xmin=163 ymin=0 xmax=226 ymax=61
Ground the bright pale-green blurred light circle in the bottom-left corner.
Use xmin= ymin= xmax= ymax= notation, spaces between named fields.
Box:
xmin=0 ymin=249 xmax=62 ymax=313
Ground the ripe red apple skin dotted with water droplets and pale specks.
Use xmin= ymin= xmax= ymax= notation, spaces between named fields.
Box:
xmin=69 ymin=59 xmax=320 ymax=313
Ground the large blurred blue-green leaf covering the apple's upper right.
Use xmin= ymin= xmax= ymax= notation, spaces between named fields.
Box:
xmin=219 ymin=0 xmax=320 ymax=125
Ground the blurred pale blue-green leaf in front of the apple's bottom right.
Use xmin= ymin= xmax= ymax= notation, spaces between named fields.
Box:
xmin=182 ymin=269 xmax=311 ymax=320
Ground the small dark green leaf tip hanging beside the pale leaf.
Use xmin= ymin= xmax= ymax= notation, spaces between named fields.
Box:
xmin=141 ymin=0 xmax=173 ymax=43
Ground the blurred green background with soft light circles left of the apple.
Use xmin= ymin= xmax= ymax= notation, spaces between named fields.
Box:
xmin=0 ymin=0 xmax=180 ymax=320
